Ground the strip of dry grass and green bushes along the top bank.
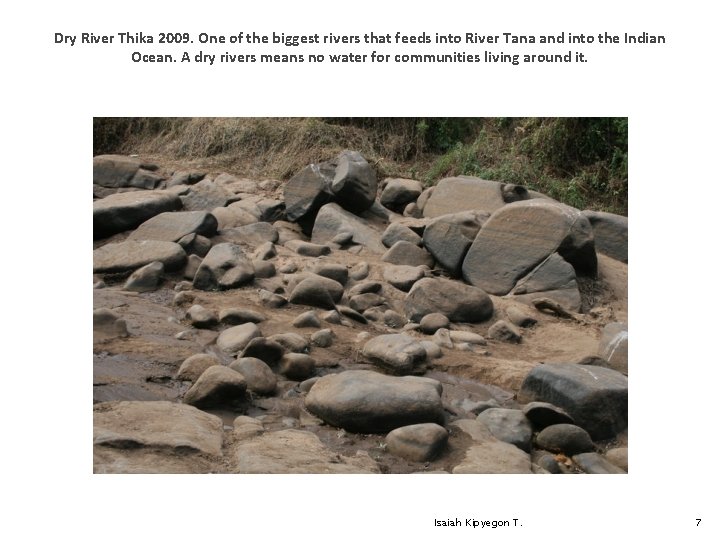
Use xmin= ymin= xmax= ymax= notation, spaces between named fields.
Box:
xmin=93 ymin=118 xmax=628 ymax=215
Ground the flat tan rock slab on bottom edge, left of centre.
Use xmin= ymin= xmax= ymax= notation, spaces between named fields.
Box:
xmin=234 ymin=429 xmax=380 ymax=474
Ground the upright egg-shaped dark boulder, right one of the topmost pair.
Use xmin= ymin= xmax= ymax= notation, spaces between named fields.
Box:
xmin=330 ymin=151 xmax=377 ymax=214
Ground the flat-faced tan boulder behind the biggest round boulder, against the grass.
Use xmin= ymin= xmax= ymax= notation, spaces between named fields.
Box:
xmin=423 ymin=176 xmax=530 ymax=217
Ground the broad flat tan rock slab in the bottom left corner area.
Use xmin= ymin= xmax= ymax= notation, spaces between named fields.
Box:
xmin=93 ymin=401 xmax=222 ymax=456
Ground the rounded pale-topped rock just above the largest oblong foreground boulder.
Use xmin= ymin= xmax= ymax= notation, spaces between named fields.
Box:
xmin=362 ymin=334 xmax=427 ymax=375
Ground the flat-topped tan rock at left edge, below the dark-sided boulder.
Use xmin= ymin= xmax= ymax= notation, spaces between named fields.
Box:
xmin=93 ymin=240 xmax=187 ymax=274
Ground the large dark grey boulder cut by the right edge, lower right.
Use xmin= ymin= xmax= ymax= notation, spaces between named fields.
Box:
xmin=519 ymin=364 xmax=628 ymax=440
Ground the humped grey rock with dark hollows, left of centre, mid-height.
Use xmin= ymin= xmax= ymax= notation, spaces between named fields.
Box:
xmin=193 ymin=243 xmax=255 ymax=291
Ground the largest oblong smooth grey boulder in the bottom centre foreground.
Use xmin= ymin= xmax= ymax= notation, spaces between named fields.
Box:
xmin=305 ymin=370 xmax=444 ymax=433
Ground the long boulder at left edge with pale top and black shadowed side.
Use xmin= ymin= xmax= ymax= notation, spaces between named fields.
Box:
xmin=93 ymin=191 xmax=182 ymax=238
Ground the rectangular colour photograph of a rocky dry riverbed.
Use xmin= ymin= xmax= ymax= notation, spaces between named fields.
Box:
xmin=93 ymin=116 xmax=632 ymax=472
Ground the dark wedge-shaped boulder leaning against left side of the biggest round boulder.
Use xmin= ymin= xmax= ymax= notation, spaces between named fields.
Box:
xmin=423 ymin=211 xmax=490 ymax=276
